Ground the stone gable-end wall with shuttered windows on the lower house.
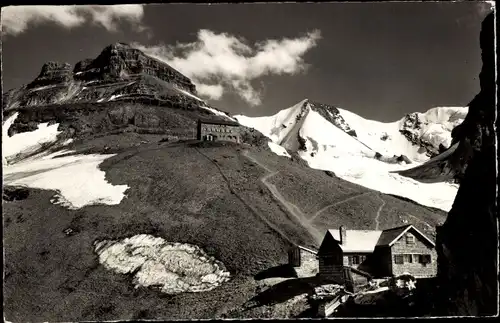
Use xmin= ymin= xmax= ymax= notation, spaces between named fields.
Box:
xmin=391 ymin=230 xmax=437 ymax=278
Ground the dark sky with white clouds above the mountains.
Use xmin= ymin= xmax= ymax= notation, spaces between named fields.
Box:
xmin=2 ymin=1 xmax=491 ymax=122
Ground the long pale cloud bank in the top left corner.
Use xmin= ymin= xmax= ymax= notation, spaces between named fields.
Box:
xmin=2 ymin=4 xmax=147 ymax=36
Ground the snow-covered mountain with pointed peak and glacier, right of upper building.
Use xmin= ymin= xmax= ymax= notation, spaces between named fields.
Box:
xmin=234 ymin=99 xmax=467 ymax=211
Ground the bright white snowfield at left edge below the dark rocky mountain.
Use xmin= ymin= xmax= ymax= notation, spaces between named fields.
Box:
xmin=2 ymin=114 xmax=129 ymax=209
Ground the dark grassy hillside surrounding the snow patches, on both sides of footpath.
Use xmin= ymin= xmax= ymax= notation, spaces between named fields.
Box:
xmin=3 ymin=134 xmax=444 ymax=321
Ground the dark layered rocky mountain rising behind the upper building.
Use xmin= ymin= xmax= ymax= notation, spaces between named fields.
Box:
xmin=2 ymin=43 xmax=267 ymax=145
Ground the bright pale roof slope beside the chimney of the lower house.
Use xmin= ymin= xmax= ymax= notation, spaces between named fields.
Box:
xmin=328 ymin=229 xmax=382 ymax=252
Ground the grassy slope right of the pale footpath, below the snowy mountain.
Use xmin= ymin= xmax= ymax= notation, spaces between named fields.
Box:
xmin=249 ymin=150 xmax=446 ymax=237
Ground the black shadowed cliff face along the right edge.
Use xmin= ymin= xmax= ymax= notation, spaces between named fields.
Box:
xmin=435 ymin=13 xmax=498 ymax=316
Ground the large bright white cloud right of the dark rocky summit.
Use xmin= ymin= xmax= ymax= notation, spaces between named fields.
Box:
xmin=132 ymin=29 xmax=321 ymax=106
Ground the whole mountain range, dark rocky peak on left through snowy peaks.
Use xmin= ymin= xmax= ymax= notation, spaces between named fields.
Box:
xmin=3 ymin=43 xmax=467 ymax=210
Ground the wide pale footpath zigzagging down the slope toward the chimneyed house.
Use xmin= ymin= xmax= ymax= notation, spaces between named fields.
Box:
xmin=242 ymin=150 xmax=323 ymax=244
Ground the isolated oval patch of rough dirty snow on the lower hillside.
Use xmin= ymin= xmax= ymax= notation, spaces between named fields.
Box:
xmin=94 ymin=234 xmax=230 ymax=294
